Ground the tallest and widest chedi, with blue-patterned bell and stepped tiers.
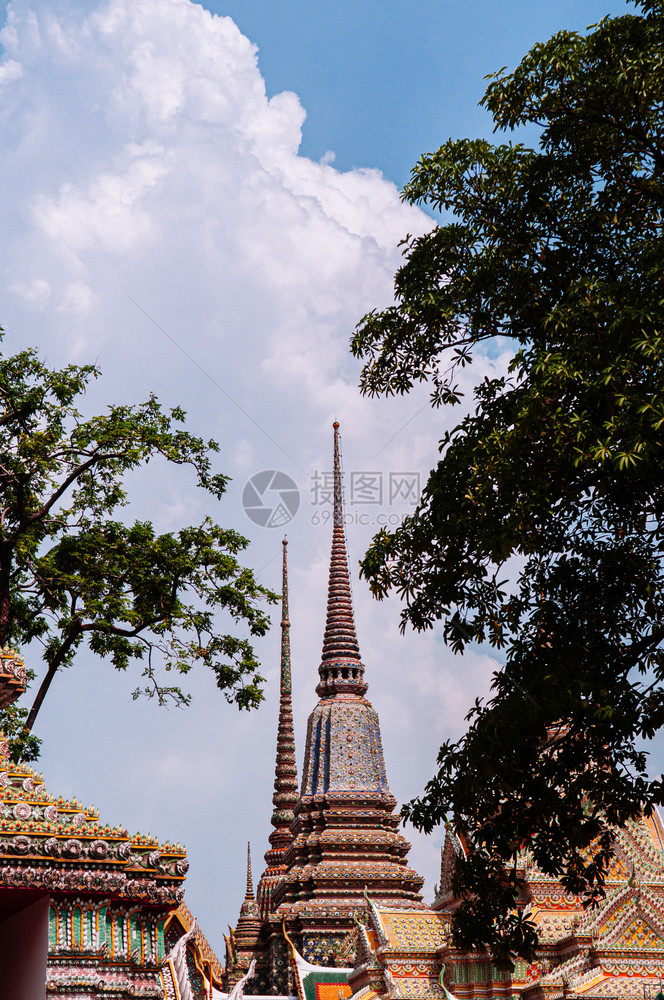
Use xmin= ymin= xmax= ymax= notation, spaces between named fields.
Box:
xmin=272 ymin=423 xmax=423 ymax=964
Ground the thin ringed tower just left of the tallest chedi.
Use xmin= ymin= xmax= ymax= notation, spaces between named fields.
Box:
xmin=258 ymin=538 xmax=298 ymax=919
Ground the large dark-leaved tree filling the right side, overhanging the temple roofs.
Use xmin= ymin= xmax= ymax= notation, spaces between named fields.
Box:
xmin=352 ymin=0 xmax=664 ymax=963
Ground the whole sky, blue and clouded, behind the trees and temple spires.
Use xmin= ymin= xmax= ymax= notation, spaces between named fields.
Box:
xmin=0 ymin=0 xmax=648 ymax=959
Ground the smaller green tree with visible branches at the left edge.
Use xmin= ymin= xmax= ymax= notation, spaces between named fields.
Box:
xmin=0 ymin=340 xmax=274 ymax=759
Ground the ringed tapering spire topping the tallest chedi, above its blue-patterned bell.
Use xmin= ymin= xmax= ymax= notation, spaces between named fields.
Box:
xmin=316 ymin=421 xmax=367 ymax=698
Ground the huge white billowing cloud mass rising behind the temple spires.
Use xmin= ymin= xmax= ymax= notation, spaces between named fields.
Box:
xmin=0 ymin=0 xmax=505 ymax=943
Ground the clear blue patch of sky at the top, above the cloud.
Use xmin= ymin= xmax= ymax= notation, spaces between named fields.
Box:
xmin=204 ymin=0 xmax=634 ymax=187
